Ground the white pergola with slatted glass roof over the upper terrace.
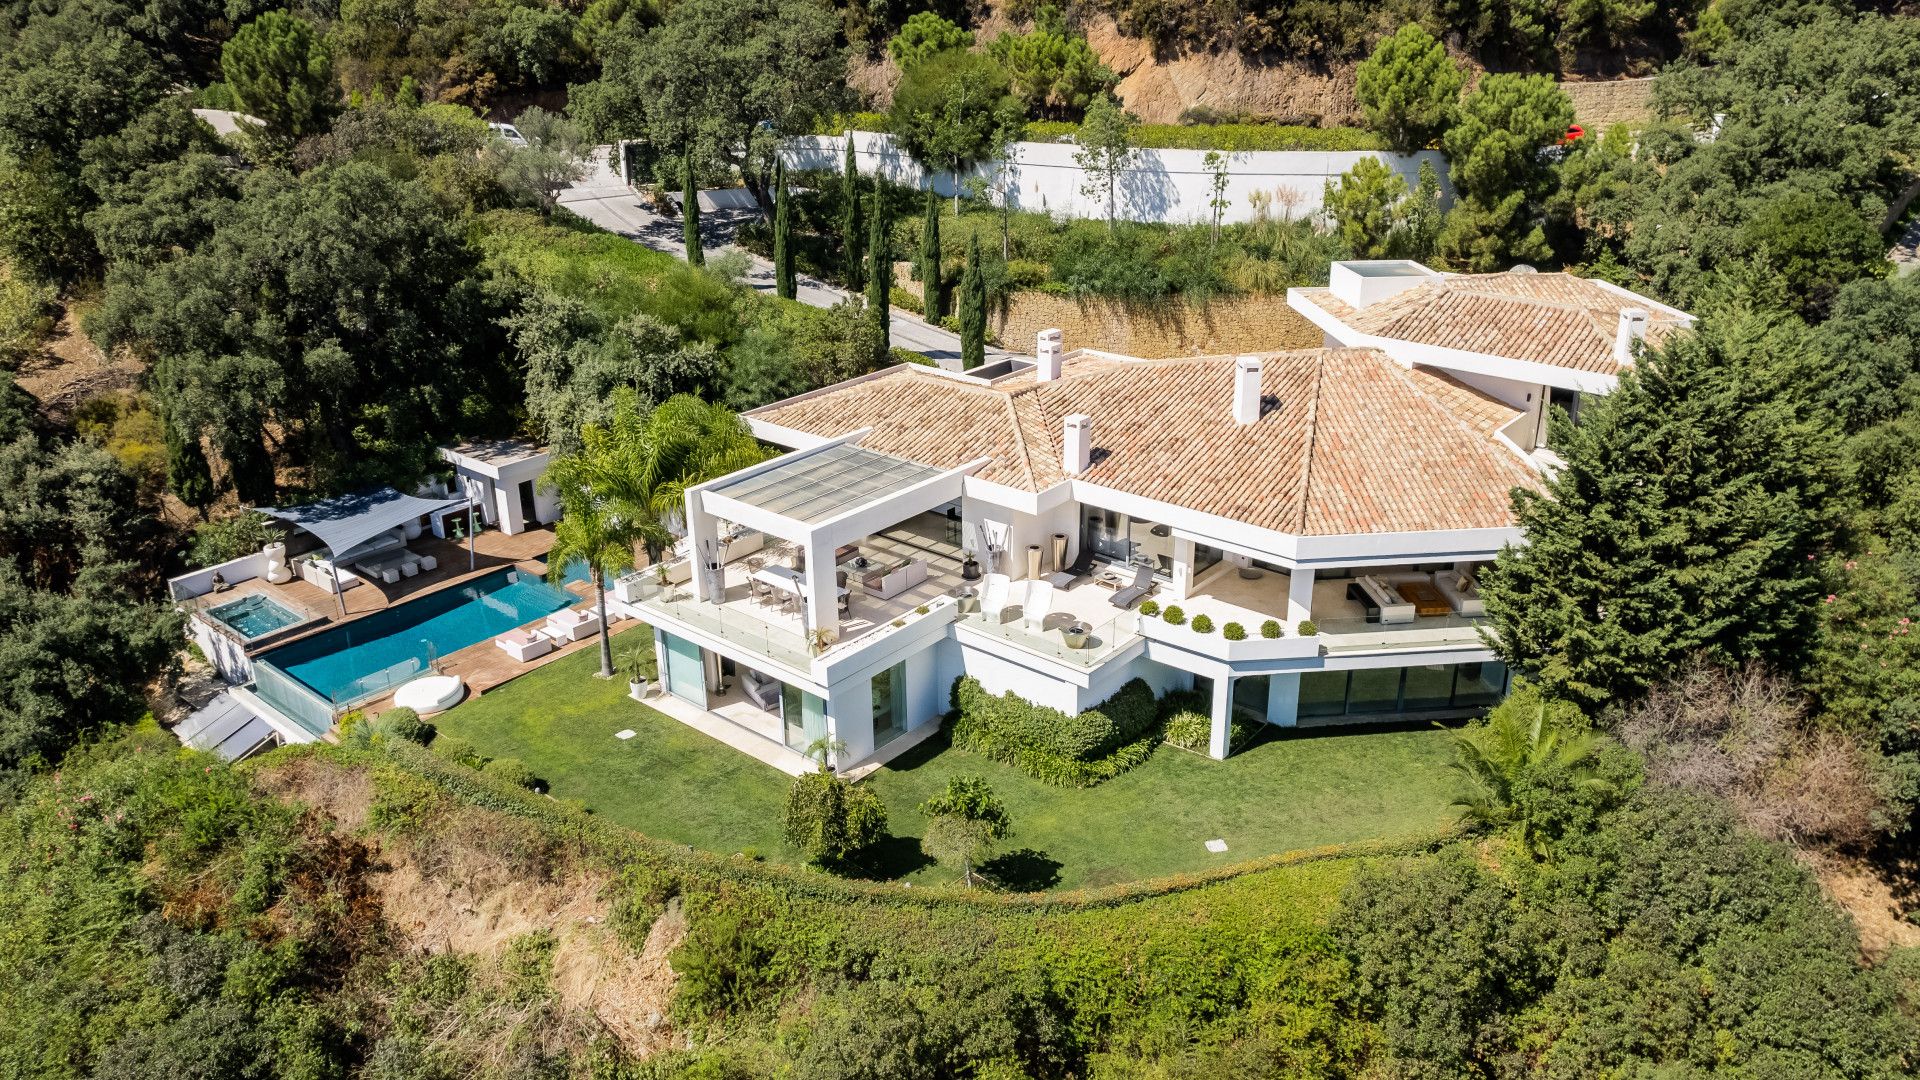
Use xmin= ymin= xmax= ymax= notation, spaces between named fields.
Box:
xmin=687 ymin=429 xmax=989 ymax=636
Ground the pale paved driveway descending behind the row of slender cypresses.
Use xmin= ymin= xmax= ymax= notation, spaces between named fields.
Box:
xmin=561 ymin=146 xmax=1018 ymax=371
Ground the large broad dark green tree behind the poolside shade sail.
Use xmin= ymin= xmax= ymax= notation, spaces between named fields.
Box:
xmin=90 ymin=161 xmax=513 ymax=505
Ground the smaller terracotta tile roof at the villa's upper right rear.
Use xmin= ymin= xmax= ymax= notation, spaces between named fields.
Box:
xmin=1300 ymin=271 xmax=1688 ymax=375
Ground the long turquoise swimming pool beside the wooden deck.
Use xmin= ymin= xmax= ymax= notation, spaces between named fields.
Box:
xmin=253 ymin=569 xmax=576 ymax=711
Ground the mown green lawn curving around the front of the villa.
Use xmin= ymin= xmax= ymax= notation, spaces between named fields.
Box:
xmin=436 ymin=638 xmax=1452 ymax=888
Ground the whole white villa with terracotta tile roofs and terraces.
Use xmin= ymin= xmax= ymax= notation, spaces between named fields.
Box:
xmin=616 ymin=261 xmax=1692 ymax=771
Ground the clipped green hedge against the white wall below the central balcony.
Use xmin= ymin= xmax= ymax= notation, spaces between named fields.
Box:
xmin=952 ymin=676 xmax=1158 ymax=788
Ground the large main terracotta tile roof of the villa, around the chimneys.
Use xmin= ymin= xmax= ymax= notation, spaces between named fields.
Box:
xmin=747 ymin=350 xmax=1540 ymax=536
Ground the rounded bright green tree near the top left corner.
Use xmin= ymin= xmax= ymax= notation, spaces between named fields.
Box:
xmin=221 ymin=12 xmax=340 ymax=138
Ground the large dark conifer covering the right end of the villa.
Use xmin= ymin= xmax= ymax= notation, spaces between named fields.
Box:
xmin=1480 ymin=319 xmax=1839 ymax=707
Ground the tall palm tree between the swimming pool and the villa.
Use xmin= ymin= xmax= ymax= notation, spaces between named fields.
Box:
xmin=541 ymin=388 xmax=766 ymax=678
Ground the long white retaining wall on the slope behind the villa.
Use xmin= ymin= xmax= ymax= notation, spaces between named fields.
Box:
xmin=781 ymin=131 xmax=1453 ymax=225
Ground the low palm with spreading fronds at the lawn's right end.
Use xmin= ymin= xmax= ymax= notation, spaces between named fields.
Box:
xmin=1450 ymin=686 xmax=1615 ymax=847
